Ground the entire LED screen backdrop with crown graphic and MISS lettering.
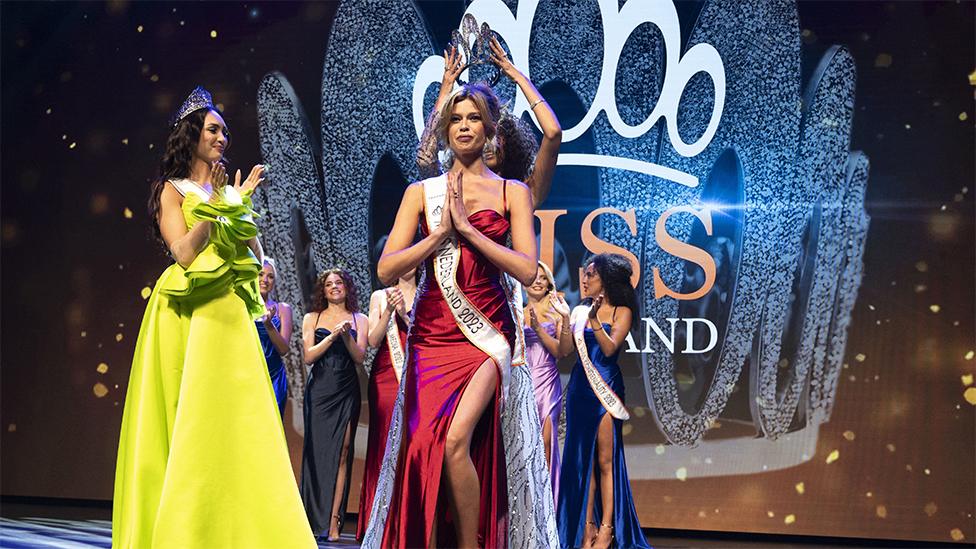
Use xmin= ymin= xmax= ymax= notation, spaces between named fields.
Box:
xmin=0 ymin=0 xmax=976 ymax=541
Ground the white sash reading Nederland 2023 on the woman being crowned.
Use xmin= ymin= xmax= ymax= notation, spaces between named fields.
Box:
xmin=423 ymin=175 xmax=512 ymax=402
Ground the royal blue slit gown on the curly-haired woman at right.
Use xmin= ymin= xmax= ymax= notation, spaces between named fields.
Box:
xmin=556 ymin=324 xmax=650 ymax=549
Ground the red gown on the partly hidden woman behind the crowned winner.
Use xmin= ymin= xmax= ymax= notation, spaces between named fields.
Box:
xmin=356 ymin=312 xmax=407 ymax=540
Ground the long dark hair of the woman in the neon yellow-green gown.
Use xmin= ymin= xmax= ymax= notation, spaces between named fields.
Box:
xmin=148 ymin=108 xmax=230 ymax=247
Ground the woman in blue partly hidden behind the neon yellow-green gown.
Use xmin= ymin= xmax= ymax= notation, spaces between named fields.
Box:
xmin=254 ymin=257 xmax=293 ymax=417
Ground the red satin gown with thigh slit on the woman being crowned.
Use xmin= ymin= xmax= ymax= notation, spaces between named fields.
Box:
xmin=383 ymin=210 xmax=516 ymax=549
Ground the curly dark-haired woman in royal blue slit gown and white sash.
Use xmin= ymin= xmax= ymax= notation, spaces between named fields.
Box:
xmin=556 ymin=254 xmax=649 ymax=549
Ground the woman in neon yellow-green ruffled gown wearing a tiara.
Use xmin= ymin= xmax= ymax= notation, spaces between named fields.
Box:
xmin=112 ymin=88 xmax=316 ymax=549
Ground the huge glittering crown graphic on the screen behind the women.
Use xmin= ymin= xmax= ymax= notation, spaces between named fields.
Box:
xmin=258 ymin=0 xmax=869 ymax=478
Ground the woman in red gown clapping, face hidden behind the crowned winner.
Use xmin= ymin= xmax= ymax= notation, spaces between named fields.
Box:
xmin=356 ymin=269 xmax=417 ymax=541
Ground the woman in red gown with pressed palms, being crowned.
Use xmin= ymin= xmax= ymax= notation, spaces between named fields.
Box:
xmin=377 ymin=84 xmax=536 ymax=548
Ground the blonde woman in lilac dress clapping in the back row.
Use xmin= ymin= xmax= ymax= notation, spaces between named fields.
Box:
xmin=523 ymin=261 xmax=573 ymax=498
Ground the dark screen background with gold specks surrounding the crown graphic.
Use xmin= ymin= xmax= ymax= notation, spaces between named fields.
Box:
xmin=0 ymin=0 xmax=976 ymax=542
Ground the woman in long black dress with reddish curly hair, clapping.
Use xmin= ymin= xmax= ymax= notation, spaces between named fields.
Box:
xmin=301 ymin=269 xmax=367 ymax=541
